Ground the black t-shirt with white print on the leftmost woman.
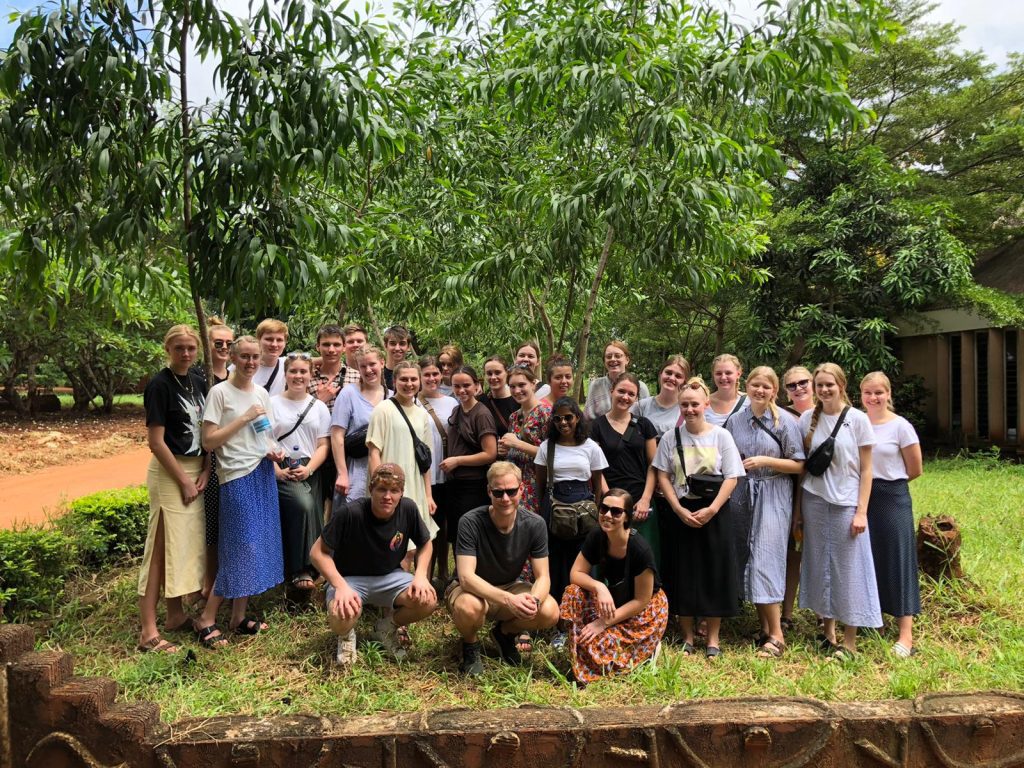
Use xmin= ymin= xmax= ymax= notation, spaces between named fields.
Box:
xmin=142 ymin=368 xmax=206 ymax=456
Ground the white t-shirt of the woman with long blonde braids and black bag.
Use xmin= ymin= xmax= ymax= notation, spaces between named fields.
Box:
xmin=800 ymin=408 xmax=874 ymax=507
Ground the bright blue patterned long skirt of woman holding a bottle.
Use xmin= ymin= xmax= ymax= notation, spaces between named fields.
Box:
xmin=213 ymin=459 xmax=285 ymax=599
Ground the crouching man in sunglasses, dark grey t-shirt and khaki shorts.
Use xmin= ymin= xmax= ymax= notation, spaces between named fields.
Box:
xmin=445 ymin=462 xmax=558 ymax=675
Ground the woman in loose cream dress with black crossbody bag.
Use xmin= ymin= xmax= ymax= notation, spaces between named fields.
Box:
xmin=367 ymin=360 xmax=437 ymax=536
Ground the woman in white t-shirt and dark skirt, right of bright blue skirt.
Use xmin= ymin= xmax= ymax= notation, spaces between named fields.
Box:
xmin=270 ymin=352 xmax=331 ymax=590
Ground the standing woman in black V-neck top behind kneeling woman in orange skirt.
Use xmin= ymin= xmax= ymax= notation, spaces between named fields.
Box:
xmin=590 ymin=373 xmax=657 ymax=544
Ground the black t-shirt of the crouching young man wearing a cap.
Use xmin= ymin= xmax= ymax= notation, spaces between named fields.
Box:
xmin=323 ymin=497 xmax=430 ymax=577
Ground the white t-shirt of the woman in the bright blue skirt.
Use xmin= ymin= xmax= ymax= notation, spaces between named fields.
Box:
xmin=203 ymin=381 xmax=274 ymax=483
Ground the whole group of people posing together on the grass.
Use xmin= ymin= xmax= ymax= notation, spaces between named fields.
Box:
xmin=138 ymin=319 xmax=922 ymax=684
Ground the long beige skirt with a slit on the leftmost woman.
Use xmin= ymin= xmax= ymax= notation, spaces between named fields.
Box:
xmin=138 ymin=456 xmax=206 ymax=597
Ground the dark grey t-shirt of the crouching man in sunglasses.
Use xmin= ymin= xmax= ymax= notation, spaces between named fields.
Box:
xmin=455 ymin=507 xmax=548 ymax=587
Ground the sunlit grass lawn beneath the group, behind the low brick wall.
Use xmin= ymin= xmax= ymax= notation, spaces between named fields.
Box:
xmin=40 ymin=450 xmax=1024 ymax=722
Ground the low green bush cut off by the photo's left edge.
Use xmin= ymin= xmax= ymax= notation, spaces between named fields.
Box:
xmin=0 ymin=527 xmax=78 ymax=621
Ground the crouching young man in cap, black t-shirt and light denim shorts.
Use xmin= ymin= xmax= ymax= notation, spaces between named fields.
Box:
xmin=310 ymin=464 xmax=437 ymax=666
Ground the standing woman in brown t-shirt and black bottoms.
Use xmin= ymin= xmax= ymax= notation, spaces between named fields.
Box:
xmin=436 ymin=366 xmax=498 ymax=573
